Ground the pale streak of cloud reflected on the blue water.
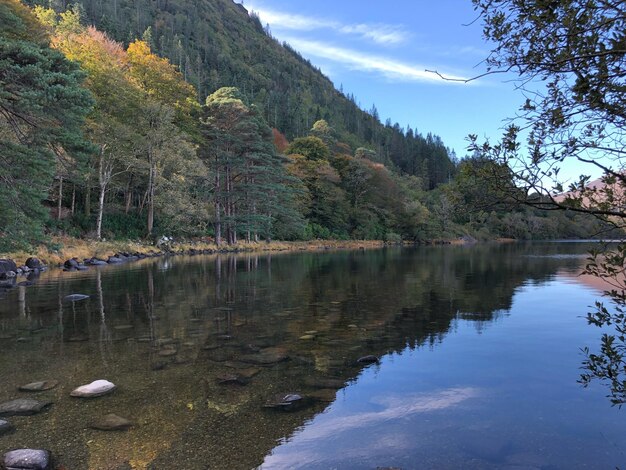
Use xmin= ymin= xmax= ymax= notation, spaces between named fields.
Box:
xmin=261 ymin=387 xmax=479 ymax=469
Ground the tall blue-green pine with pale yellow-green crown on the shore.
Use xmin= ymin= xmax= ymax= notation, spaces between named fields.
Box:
xmin=201 ymin=88 xmax=302 ymax=244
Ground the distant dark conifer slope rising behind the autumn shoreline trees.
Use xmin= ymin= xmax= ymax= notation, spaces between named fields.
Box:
xmin=23 ymin=0 xmax=454 ymax=189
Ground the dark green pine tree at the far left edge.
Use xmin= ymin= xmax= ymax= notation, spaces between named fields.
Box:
xmin=0 ymin=0 xmax=93 ymax=248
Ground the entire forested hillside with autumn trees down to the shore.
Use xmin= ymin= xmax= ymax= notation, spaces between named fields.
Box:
xmin=0 ymin=0 xmax=616 ymax=250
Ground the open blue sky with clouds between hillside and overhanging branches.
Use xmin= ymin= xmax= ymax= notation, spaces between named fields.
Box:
xmin=235 ymin=0 xmax=523 ymax=157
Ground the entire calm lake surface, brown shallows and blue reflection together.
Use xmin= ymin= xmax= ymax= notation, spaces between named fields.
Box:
xmin=0 ymin=243 xmax=626 ymax=470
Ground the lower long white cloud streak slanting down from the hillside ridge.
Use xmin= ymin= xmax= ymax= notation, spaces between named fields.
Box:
xmin=285 ymin=38 xmax=465 ymax=84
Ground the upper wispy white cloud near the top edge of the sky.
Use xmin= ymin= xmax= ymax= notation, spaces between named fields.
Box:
xmin=251 ymin=6 xmax=411 ymax=45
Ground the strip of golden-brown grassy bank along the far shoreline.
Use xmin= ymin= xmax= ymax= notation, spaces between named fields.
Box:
xmin=0 ymin=237 xmax=394 ymax=266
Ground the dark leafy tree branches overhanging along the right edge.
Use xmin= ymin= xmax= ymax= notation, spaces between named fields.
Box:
xmin=471 ymin=0 xmax=626 ymax=405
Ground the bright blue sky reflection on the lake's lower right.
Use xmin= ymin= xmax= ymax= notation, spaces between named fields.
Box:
xmin=262 ymin=276 xmax=626 ymax=469
